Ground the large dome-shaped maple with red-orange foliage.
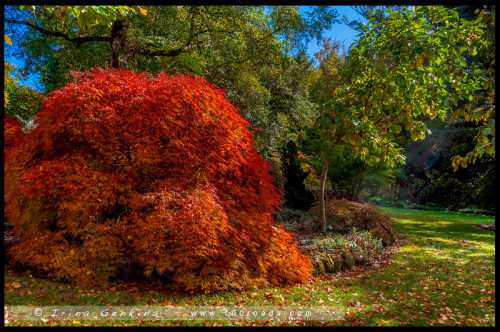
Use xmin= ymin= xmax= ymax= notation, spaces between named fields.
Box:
xmin=5 ymin=69 xmax=312 ymax=291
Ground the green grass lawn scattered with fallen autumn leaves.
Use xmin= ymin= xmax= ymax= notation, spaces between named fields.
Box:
xmin=5 ymin=208 xmax=495 ymax=326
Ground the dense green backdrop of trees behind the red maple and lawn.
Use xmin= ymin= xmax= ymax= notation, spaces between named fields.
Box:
xmin=4 ymin=6 xmax=495 ymax=218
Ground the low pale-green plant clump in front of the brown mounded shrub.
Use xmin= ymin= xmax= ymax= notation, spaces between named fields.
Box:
xmin=302 ymin=228 xmax=383 ymax=275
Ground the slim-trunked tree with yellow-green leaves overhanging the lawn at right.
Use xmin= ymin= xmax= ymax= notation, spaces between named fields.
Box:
xmin=310 ymin=7 xmax=495 ymax=230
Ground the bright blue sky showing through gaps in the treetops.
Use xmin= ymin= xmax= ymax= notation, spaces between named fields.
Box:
xmin=4 ymin=6 xmax=359 ymax=91
